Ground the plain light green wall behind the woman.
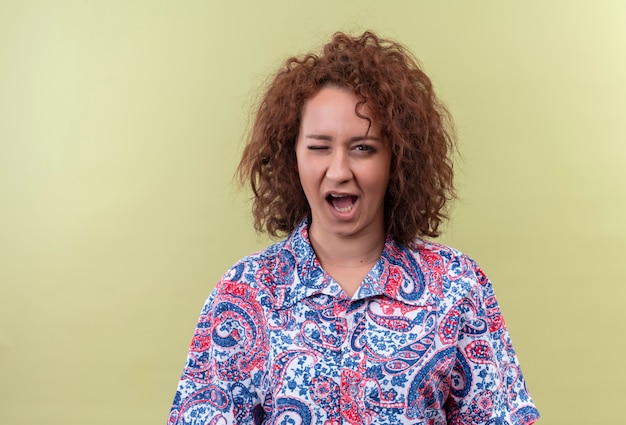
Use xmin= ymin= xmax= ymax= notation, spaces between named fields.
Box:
xmin=0 ymin=0 xmax=626 ymax=425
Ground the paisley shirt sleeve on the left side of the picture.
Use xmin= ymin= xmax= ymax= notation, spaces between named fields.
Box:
xmin=168 ymin=280 xmax=267 ymax=425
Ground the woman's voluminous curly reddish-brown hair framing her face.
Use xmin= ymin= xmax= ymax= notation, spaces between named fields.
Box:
xmin=237 ymin=31 xmax=456 ymax=244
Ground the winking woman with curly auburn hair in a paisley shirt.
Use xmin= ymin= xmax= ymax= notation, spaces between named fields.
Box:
xmin=169 ymin=32 xmax=539 ymax=425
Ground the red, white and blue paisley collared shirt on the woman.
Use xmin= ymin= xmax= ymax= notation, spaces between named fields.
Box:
xmin=169 ymin=222 xmax=539 ymax=425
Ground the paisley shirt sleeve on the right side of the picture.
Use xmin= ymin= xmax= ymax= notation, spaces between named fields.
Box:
xmin=446 ymin=264 xmax=539 ymax=425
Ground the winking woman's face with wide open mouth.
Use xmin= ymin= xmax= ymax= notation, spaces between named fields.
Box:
xmin=296 ymin=87 xmax=391 ymax=237
